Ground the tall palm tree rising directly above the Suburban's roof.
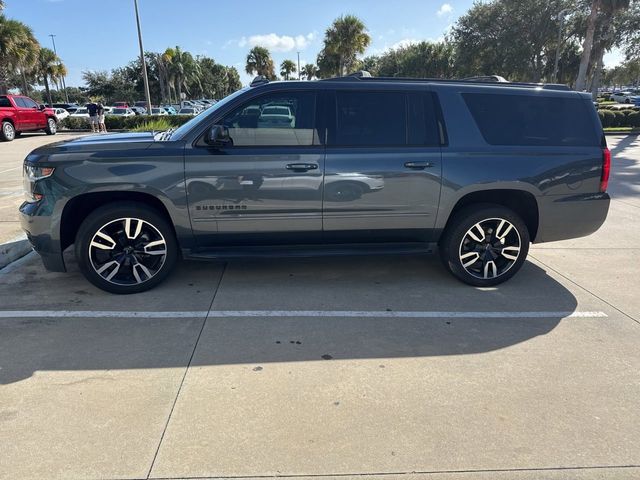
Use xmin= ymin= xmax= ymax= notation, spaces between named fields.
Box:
xmin=317 ymin=15 xmax=371 ymax=76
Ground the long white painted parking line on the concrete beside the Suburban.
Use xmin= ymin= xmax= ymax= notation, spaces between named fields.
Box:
xmin=0 ymin=310 xmax=607 ymax=318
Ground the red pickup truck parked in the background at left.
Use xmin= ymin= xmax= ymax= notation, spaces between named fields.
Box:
xmin=0 ymin=95 xmax=58 ymax=142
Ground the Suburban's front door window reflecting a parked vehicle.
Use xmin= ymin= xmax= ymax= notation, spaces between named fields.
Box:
xmin=222 ymin=92 xmax=315 ymax=147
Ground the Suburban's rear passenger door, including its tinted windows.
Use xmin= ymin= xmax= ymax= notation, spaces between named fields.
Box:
xmin=323 ymin=89 xmax=442 ymax=242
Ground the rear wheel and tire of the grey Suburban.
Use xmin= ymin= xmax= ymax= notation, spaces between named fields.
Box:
xmin=440 ymin=204 xmax=530 ymax=287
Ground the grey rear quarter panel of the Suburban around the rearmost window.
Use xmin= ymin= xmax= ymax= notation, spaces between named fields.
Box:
xmin=435 ymin=85 xmax=602 ymax=241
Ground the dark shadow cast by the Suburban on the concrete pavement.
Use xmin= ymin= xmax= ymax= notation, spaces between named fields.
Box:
xmin=0 ymin=257 xmax=577 ymax=384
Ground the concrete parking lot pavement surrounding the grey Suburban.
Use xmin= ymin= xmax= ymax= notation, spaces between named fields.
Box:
xmin=0 ymin=135 xmax=640 ymax=480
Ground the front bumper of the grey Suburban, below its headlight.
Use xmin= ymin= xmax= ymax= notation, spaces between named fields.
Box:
xmin=20 ymin=202 xmax=67 ymax=272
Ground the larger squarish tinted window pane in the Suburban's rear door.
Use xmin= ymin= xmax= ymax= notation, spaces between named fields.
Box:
xmin=335 ymin=92 xmax=407 ymax=146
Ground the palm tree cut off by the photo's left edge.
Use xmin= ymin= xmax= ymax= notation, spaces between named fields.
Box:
xmin=0 ymin=14 xmax=38 ymax=94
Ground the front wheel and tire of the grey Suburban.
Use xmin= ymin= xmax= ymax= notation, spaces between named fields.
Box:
xmin=75 ymin=202 xmax=178 ymax=294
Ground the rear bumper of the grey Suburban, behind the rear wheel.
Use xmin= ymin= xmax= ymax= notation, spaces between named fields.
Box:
xmin=534 ymin=193 xmax=611 ymax=243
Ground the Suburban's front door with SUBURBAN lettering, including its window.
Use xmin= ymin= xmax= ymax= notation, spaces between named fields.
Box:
xmin=185 ymin=91 xmax=324 ymax=247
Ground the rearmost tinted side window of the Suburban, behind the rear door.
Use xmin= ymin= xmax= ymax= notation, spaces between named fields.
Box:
xmin=462 ymin=93 xmax=600 ymax=146
